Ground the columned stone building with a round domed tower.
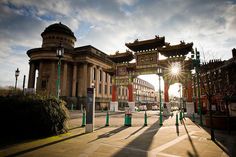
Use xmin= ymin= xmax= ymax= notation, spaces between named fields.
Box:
xmin=27 ymin=23 xmax=157 ymax=109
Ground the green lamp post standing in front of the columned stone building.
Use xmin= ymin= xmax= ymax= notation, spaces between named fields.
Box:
xmin=56 ymin=43 xmax=64 ymax=99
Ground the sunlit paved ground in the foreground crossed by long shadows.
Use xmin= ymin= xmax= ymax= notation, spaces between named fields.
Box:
xmin=0 ymin=112 xmax=236 ymax=157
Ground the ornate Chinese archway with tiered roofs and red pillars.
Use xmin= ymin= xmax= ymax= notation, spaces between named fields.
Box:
xmin=105 ymin=36 xmax=193 ymax=111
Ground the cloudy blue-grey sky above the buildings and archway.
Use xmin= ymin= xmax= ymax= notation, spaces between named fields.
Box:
xmin=0 ymin=0 xmax=236 ymax=92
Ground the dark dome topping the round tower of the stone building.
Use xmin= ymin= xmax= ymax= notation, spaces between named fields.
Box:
xmin=41 ymin=22 xmax=76 ymax=39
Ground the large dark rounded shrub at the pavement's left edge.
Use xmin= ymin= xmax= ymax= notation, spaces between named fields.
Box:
xmin=0 ymin=95 xmax=68 ymax=139
